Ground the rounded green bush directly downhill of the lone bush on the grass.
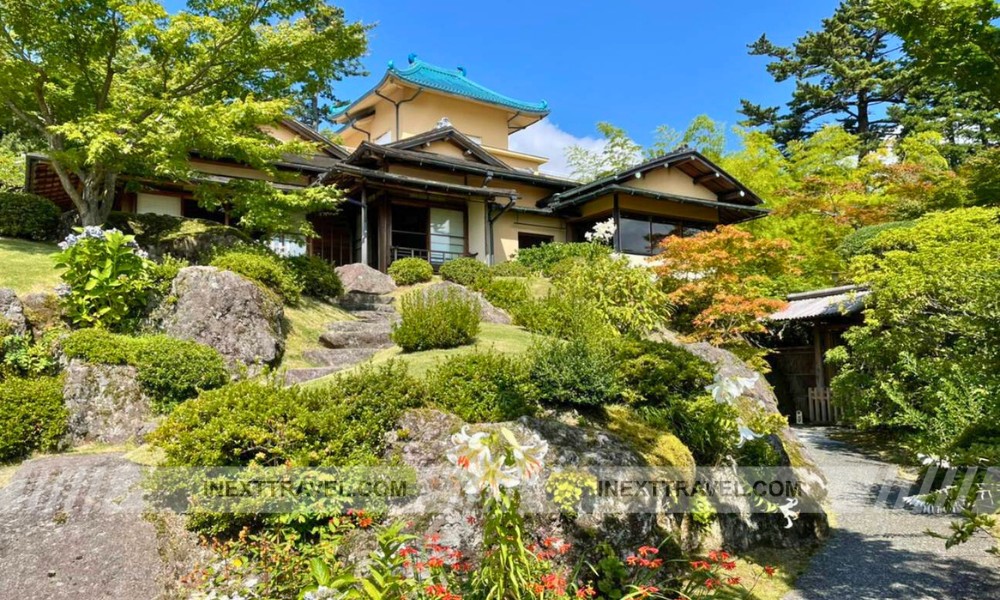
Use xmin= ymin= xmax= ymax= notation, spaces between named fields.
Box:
xmin=427 ymin=351 xmax=535 ymax=423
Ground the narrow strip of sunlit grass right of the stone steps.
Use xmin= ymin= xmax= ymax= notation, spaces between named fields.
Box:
xmin=304 ymin=323 xmax=536 ymax=387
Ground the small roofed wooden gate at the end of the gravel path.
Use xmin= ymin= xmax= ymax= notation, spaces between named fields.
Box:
xmin=768 ymin=286 xmax=869 ymax=424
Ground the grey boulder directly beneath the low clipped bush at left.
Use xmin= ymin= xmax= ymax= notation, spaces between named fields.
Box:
xmin=63 ymin=360 xmax=153 ymax=445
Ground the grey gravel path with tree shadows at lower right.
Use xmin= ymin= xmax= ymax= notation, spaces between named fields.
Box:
xmin=785 ymin=428 xmax=1000 ymax=600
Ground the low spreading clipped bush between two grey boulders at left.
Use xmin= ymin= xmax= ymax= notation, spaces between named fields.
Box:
xmin=62 ymin=329 xmax=229 ymax=412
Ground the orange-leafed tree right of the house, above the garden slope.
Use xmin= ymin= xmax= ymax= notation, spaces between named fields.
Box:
xmin=654 ymin=226 xmax=799 ymax=367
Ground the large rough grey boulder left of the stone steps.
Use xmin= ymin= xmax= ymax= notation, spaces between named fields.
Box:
xmin=154 ymin=267 xmax=285 ymax=375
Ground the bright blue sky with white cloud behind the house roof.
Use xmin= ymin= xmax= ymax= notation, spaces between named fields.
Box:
xmin=167 ymin=0 xmax=837 ymax=171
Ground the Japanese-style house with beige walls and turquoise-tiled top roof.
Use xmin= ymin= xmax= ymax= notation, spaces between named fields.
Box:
xmin=28 ymin=55 xmax=767 ymax=270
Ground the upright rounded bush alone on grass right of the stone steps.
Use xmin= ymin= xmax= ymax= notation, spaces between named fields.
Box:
xmin=392 ymin=288 xmax=480 ymax=352
